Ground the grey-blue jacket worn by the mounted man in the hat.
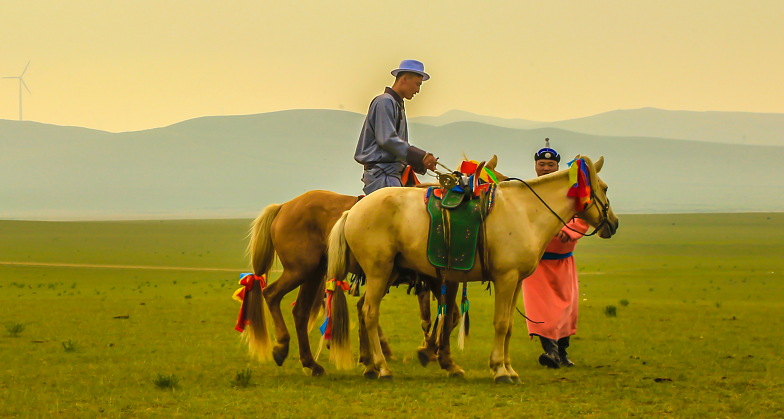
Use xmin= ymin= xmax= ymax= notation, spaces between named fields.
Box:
xmin=354 ymin=87 xmax=426 ymax=194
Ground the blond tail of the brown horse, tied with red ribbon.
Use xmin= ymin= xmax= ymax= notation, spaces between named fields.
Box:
xmin=243 ymin=204 xmax=282 ymax=361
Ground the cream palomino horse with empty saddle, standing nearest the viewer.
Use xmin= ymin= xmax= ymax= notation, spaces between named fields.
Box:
xmin=328 ymin=156 xmax=618 ymax=383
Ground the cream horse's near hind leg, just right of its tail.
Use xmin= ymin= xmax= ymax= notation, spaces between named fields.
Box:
xmin=362 ymin=269 xmax=397 ymax=380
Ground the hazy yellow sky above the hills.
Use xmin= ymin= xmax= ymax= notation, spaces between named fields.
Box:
xmin=0 ymin=0 xmax=784 ymax=131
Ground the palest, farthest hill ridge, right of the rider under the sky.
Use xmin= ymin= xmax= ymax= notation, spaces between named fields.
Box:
xmin=411 ymin=108 xmax=784 ymax=146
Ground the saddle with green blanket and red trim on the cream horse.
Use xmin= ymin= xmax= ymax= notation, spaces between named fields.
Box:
xmin=425 ymin=161 xmax=497 ymax=271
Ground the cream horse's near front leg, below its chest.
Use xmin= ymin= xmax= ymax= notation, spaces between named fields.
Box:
xmin=489 ymin=271 xmax=519 ymax=383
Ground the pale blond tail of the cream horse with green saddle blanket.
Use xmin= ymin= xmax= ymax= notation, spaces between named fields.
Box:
xmin=327 ymin=211 xmax=354 ymax=369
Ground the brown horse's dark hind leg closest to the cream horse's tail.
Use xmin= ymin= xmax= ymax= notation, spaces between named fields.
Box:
xmin=292 ymin=270 xmax=325 ymax=377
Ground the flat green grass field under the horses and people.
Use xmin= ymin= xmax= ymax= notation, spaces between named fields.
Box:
xmin=0 ymin=213 xmax=784 ymax=418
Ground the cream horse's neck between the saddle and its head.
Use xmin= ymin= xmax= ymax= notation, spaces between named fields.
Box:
xmin=504 ymin=170 xmax=576 ymax=249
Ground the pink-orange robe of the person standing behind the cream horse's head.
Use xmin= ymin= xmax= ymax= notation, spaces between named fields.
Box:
xmin=523 ymin=218 xmax=588 ymax=340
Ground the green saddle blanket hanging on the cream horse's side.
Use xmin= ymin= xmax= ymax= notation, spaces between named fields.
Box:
xmin=427 ymin=185 xmax=495 ymax=271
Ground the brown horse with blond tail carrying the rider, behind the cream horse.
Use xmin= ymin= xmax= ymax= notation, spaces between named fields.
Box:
xmin=246 ymin=156 xmax=506 ymax=376
